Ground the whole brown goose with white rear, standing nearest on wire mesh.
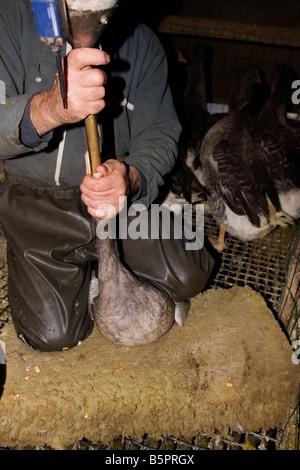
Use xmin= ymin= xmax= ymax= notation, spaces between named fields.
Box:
xmin=200 ymin=77 xmax=285 ymax=251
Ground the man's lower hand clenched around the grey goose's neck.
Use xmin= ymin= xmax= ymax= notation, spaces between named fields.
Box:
xmin=80 ymin=159 xmax=139 ymax=219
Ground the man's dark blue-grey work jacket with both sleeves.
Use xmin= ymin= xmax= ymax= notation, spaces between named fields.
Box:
xmin=0 ymin=0 xmax=181 ymax=205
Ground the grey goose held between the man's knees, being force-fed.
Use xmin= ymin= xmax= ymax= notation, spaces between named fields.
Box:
xmin=91 ymin=221 xmax=189 ymax=346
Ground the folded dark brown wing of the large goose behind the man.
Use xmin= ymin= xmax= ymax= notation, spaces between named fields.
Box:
xmin=202 ymin=117 xmax=279 ymax=226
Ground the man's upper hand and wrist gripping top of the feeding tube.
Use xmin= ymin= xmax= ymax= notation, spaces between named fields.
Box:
xmin=30 ymin=48 xmax=110 ymax=136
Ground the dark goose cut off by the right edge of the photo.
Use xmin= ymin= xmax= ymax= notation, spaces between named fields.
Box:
xmin=254 ymin=64 xmax=300 ymax=219
